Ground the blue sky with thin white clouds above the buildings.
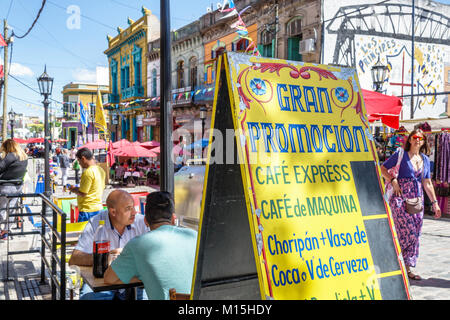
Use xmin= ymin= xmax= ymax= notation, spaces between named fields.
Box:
xmin=0 ymin=0 xmax=450 ymax=117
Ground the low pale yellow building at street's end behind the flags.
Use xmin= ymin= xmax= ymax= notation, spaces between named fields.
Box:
xmin=62 ymin=82 xmax=109 ymax=148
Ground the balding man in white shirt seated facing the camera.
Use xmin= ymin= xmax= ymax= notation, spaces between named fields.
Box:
xmin=69 ymin=190 xmax=149 ymax=300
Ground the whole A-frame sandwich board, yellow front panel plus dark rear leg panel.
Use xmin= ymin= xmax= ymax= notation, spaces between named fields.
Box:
xmin=191 ymin=53 xmax=410 ymax=300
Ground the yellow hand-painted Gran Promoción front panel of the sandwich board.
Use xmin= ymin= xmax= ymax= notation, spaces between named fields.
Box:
xmin=221 ymin=53 xmax=409 ymax=300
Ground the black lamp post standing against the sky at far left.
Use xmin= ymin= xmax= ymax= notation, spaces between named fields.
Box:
xmin=37 ymin=66 xmax=53 ymax=197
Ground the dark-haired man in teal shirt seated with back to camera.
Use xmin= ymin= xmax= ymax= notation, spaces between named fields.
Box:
xmin=104 ymin=191 xmax=197 ymax=300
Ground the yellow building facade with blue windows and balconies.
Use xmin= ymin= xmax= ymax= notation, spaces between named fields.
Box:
xmin=104 ymin=7 xmax=160 ymax=141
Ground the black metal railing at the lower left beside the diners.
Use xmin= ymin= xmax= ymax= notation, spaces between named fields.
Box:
xmin=0 ymin=193 xmax=67 ymax=300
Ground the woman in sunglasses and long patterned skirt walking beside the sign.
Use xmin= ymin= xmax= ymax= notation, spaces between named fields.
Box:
xmin=381 ymin=129 xmax=441 ymax=280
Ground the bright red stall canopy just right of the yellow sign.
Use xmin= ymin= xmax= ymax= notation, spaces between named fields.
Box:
xmin=361 ymin=89 xmax=403 ymax=129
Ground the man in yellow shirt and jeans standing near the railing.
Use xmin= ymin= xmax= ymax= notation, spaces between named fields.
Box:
xmin=69 ymin=148 xmax=106 ymax=222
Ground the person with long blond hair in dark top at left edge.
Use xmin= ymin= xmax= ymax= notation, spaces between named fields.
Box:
xmin=0 ymin=139 xmax=28 ymax=239
